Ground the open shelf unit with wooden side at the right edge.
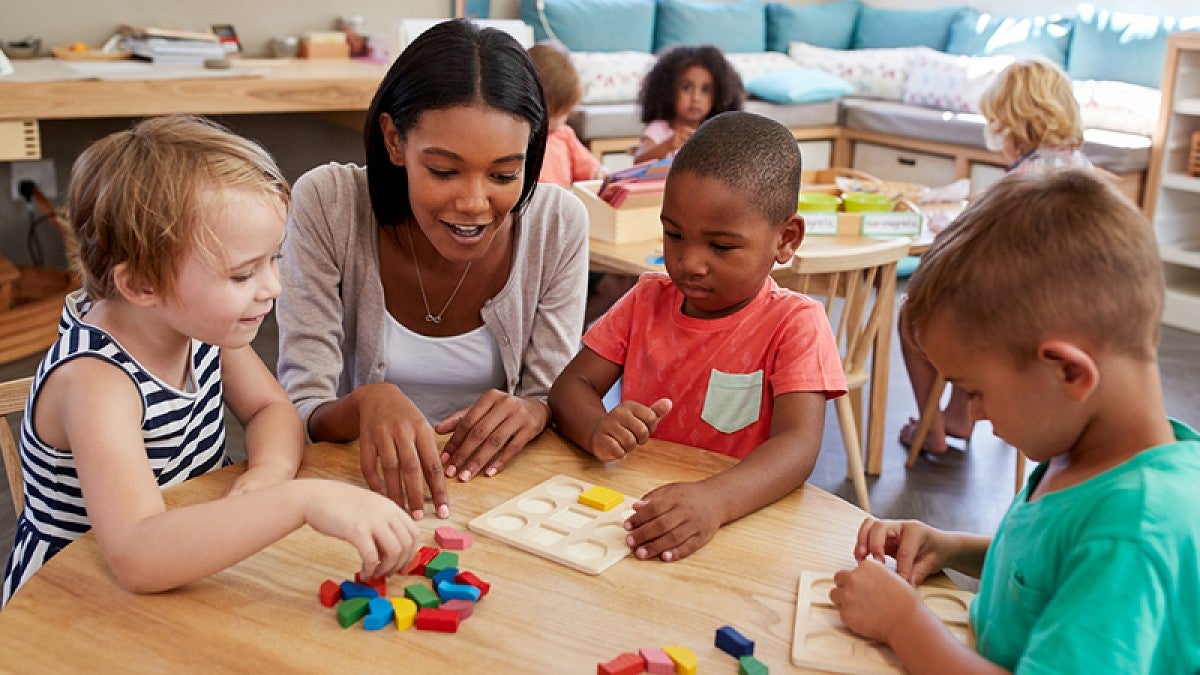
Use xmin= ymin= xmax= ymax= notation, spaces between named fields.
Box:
xmin=1145 ymin=32 xmax=1200 ymax=333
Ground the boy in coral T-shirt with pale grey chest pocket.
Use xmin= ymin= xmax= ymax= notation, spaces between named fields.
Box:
xmin=550 ymin=112 xmax=846 ymax=561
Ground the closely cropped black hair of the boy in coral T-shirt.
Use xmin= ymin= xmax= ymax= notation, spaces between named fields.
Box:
xmin=671 ymin=110 xmax=800 ymax=225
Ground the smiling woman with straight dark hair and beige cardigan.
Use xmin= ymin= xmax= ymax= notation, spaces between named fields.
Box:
xmin=277 ymin=20 xmax=588 ymax=519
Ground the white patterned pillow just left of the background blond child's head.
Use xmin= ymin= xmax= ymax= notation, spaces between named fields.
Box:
xmin=902 ymin=52 xmax=1014 ymax=113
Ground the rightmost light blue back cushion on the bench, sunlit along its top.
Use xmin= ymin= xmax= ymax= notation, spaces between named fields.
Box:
xmin=1067 ymin=5 xmax=1200 ymax=89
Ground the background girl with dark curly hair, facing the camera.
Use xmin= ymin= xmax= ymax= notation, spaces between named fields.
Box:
xmin=634 ymin=44 xmax=745 ymax=163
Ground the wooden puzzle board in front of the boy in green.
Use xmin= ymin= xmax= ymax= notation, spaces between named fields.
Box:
xmin=792 ymin=571 xmax=974 ymax=673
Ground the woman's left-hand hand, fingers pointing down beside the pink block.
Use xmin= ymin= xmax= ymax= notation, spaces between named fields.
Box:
xmin=356 ymin=382 xmax=450 ymax=520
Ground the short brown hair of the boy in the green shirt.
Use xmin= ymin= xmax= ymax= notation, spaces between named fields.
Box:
xmin=905 ymin=169 xmax=1163 ymax=364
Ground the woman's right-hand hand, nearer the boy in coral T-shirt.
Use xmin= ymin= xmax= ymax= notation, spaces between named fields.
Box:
xmin=434 ymin=389 xmax=550 ymax=482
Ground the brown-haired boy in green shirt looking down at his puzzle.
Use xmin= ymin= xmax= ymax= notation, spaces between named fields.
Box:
xmin=829 ymin=169 xmax=1200 ymax=674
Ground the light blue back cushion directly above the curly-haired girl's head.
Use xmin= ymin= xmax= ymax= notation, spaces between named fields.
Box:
xmin=654 ymin=0 xmax=767 ymax=52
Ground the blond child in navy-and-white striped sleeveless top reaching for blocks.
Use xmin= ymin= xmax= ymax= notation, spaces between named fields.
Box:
xmin=2 ymin=117 xmax=416 ymax=603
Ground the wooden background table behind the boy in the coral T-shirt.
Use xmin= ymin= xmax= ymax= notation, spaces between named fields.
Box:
xmin=588 ymin=235 xmax=929 ymax=476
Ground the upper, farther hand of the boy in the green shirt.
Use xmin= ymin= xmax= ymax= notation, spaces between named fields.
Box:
xmin=854 ymin=518 xmax=947 ymax=586
